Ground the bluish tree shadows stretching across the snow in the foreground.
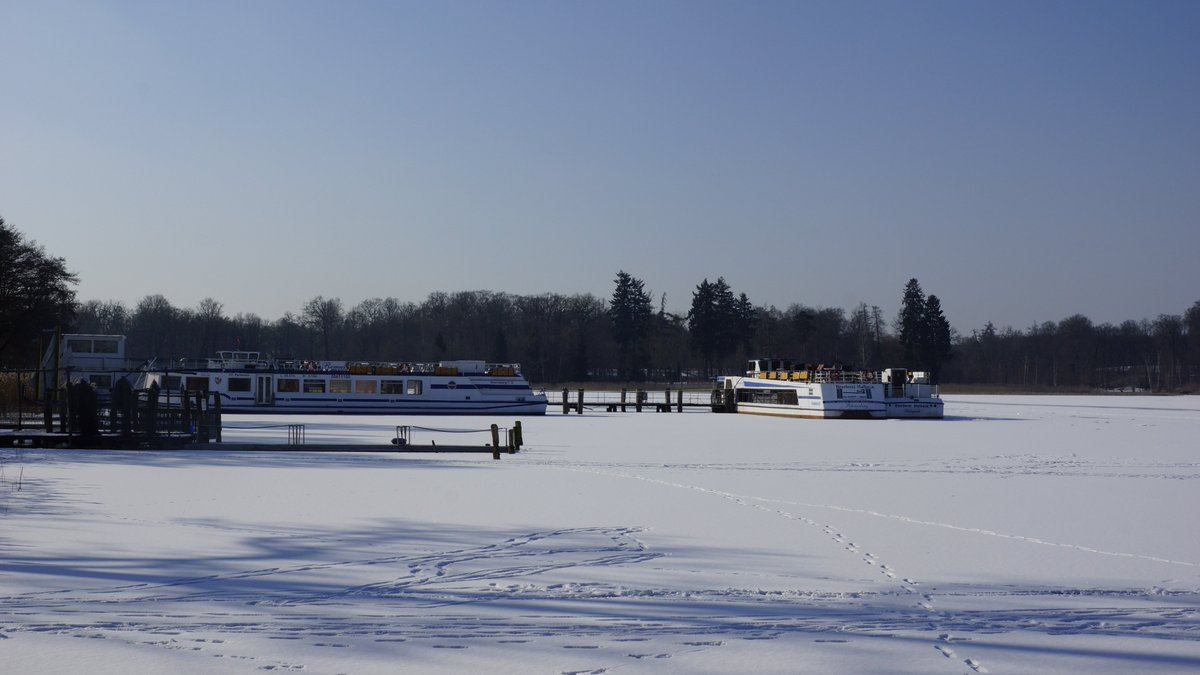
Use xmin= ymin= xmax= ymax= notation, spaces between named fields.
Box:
xmin=0 ymin=519 xmax=1200 ymax=668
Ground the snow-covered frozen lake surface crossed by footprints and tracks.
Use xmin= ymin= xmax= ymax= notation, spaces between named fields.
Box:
xmin=0 ymin=396 xmax=1200 ymax=674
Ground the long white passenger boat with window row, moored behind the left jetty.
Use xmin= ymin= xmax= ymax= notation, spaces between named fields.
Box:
xmin=140 ymin=351 xmax=546 ymax=414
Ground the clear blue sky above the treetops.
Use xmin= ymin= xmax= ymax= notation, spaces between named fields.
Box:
xmin=0 ymin=0 xmax=1200 ymax=333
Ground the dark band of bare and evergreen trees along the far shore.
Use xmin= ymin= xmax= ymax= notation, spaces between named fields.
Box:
xmin=0 ymin=219 xmax=1200 ymax=392
